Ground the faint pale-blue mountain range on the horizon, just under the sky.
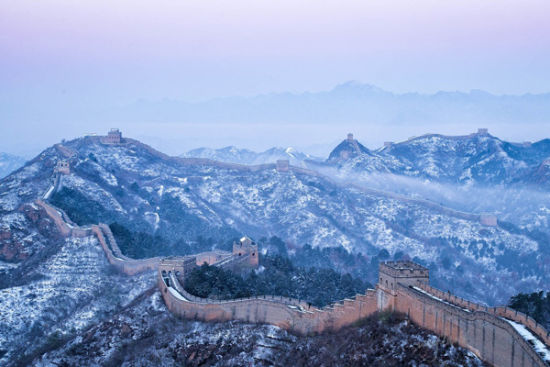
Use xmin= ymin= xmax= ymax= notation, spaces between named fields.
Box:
xmin=1 ymin=82 xmax=550 ymax=125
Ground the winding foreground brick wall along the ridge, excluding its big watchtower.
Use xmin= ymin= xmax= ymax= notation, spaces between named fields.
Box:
xmin=35 ymin=184 xmax=550 ymax=367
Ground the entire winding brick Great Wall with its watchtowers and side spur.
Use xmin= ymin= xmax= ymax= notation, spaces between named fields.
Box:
xmin=30 ymin=131 xmax=550 ymax=367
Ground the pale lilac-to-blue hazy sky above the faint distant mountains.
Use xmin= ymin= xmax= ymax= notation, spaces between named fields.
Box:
xmin=0 ymin=0 xmax=550 ymax=155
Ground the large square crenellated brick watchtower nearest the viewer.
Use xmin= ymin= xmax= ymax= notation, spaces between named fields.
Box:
xmin=376 ymin=261 xmax=430 ymax=310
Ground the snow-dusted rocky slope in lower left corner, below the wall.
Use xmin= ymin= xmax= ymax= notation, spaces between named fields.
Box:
xmin=0 ymin=231 xmax=154 ymax=366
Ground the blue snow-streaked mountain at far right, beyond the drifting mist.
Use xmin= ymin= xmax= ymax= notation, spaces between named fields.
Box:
xmin=328 ymin=130 xmax=550 ymax=189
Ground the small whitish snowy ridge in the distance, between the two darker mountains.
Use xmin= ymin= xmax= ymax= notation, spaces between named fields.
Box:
xmin=181 ymin=146 xmax=321 ymax=167
